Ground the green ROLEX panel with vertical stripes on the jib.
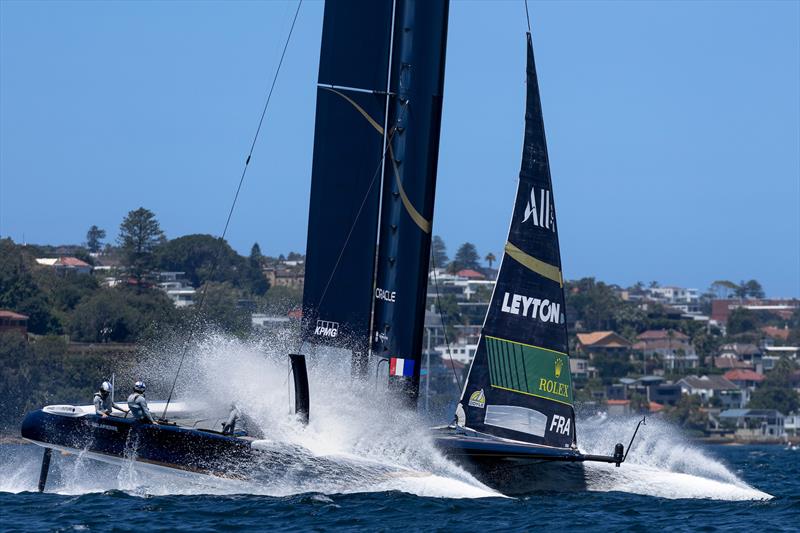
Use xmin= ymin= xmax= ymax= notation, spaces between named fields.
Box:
xmin=485 ymin=335 xmax=572 ymax=404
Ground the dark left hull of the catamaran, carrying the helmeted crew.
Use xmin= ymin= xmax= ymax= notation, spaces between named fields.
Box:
xmin=21 ymin=410 xmax=256 ymax=479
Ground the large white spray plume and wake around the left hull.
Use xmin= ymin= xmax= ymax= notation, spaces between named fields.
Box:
xmin=0 ymin=335 xmax=500 ymax=498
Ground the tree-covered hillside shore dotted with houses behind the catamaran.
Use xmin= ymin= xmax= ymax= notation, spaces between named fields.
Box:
xmin=0 ymin=208 xmax=800 ymax=439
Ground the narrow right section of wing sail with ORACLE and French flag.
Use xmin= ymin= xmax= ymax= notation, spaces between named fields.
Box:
xmin=373 ymin=0 xmax=449 ymax=404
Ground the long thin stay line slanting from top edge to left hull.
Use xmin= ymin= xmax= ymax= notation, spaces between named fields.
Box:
xmin=161 ymin=0 xmax=303 ymax=419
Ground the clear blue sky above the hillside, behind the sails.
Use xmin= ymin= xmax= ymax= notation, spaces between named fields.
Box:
xmin=0 ymin=0 xmax=800 ymax=296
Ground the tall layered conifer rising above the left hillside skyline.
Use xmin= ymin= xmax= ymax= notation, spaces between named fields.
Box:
xmin=117 ymin=207 xmax=166 ymax=280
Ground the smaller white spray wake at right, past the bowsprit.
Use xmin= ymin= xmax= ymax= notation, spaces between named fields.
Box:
xmin=578 ymin=417 xmax=772 ymax=500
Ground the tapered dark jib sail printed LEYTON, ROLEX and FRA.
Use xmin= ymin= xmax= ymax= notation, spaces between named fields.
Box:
xmin=459 ymin=34 xmax=576 ymax=447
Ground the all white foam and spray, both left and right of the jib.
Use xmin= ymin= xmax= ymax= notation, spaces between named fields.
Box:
xmin=0 ymin=335 xmax=771 ymax=500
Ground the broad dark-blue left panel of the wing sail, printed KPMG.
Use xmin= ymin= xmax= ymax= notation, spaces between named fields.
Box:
xmin=302 ymin=0 xmax=393 ymax=353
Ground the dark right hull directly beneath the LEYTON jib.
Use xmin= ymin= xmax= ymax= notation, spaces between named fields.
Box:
xmin=434 ymin=428 xmax=586 ymax=495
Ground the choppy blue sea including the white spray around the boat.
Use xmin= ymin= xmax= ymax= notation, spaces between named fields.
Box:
xmin=0 ymin=336 xmax=800 ymax=531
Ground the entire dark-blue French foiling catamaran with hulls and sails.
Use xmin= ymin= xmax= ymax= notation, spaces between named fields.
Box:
xmin=22 ymin=0 xmax=638 ymax=493
